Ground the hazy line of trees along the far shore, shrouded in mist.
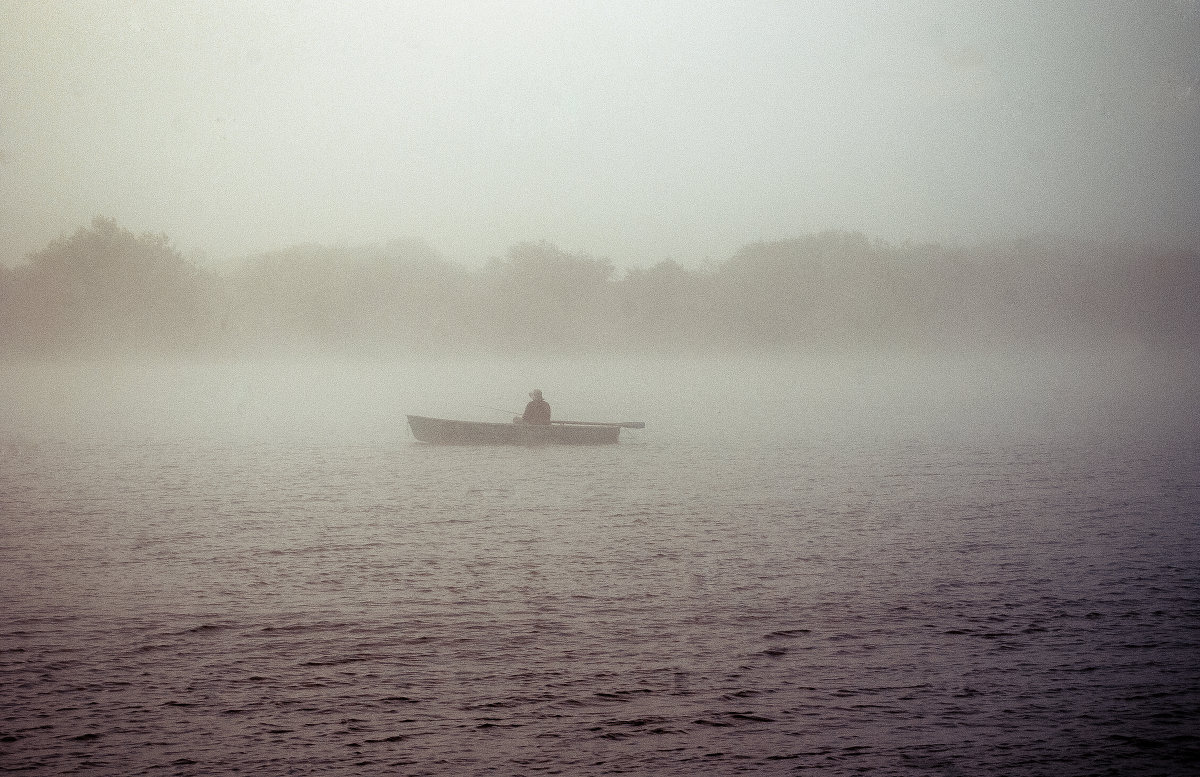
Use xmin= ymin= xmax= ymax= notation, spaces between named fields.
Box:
xmin=0 ymin=218 xmax=1200 ymax=357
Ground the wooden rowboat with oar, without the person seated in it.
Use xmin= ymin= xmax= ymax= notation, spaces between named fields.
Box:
xmin=408 ymin=415 xmax=646 ymax=445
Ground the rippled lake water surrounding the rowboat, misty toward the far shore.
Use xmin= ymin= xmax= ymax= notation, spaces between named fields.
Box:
xmin=0 ymin=354 xmax=1200 ymax=776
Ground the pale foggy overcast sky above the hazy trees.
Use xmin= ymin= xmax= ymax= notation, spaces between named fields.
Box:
xmin=0 ymin=0 xmax=1200 ymax=265
